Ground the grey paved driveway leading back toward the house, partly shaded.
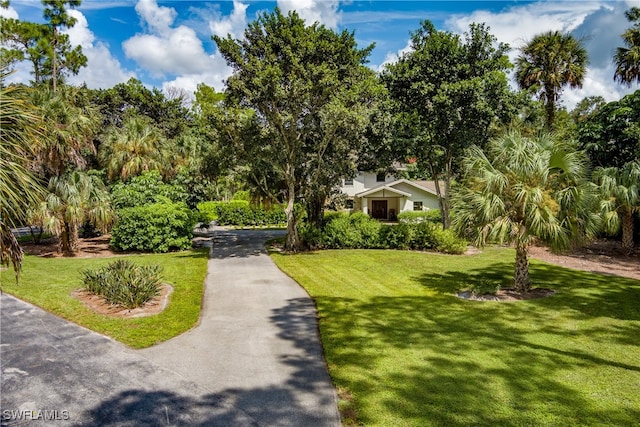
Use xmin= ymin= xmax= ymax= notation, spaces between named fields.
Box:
xmin=0 ymin=230 xmax=340 ymax=426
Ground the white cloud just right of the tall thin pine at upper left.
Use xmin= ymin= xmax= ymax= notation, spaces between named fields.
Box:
xmin=64 ymin=10 xmax=135 ymax=89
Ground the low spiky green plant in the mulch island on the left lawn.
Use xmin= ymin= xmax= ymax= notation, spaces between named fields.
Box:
xmin=81 ymin=259 xmax=162 ymax=308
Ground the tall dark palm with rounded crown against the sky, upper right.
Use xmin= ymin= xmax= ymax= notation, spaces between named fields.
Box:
xmin=516 ymin=31 xmax=588 ymax=129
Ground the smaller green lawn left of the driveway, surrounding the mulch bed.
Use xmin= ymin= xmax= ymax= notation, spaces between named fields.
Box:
xmin=0 ymin=249 xmax=208 ymax=348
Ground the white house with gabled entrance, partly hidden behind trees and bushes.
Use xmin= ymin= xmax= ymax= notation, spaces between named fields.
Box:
xmin=340 ymin=172 xmax=439 ymax=221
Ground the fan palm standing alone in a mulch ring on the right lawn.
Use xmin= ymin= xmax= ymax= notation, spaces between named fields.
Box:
xmin=453 ymin=131 xmax=597 ymax=292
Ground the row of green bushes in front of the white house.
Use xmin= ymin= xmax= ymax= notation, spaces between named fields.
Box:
xmin=300 ymin=212 xmax=467 ymax=254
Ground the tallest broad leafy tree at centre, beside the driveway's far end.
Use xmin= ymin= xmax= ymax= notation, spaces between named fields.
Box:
xmin=214 ymin=9 xmax=378 ymax=250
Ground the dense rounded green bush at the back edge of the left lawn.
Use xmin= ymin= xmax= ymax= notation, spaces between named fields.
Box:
xmin=111 ymin=202 xmax=197 ymax=252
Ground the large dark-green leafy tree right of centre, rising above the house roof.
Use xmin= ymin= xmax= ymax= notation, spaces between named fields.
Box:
xmin=382 ymin=21 xmax=513 ymax=227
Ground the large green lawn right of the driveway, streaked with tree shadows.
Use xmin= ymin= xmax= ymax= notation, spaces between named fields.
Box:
xmin=272 ymin=248 xmax=640 ymax=426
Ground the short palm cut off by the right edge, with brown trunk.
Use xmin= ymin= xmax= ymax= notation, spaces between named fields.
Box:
xmin=593 ymin=160 xmax=640 ymax=254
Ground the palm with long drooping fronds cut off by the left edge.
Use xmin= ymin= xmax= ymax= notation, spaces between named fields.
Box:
xmin=0 ymin=76 xmax=44 ymax=280
